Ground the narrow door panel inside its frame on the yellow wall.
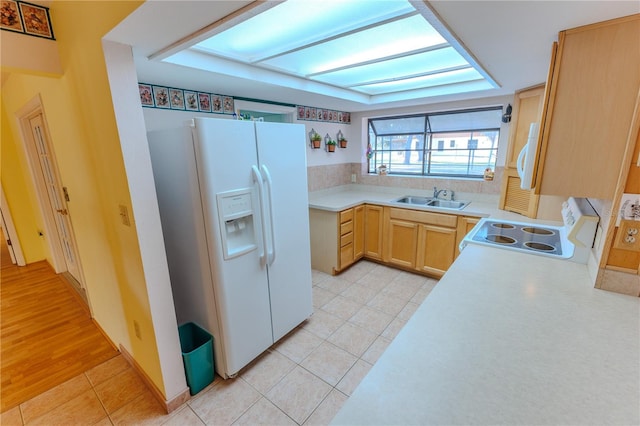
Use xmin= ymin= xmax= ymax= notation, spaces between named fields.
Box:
xmin=29 ymin=113 xmax=84 ymax=287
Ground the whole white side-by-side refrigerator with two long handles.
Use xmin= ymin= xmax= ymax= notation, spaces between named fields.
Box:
xmin=148 ymin=118 xmax=313 ymax=378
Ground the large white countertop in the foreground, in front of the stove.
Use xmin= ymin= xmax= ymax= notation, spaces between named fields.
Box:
xmin=332 ymin=245 xmax=640 ymax=425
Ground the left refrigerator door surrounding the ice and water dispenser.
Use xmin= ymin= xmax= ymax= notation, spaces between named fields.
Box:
xmin=194 ymin=118 xmax=273 ymax=376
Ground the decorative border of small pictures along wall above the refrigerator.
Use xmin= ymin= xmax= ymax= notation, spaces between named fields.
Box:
xmin=138 ymin=82 xmax=351 ymax=124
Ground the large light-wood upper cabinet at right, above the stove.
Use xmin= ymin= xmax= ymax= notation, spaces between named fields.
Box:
xmin=528 ymin=14 xmax=640 ymax=199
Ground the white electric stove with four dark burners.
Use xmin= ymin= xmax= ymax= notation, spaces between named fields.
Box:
xmin=460 ymin=197 xmax=599 ymax=263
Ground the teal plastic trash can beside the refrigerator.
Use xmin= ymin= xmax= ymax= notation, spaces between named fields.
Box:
xmin=178 ymin=322 xmax=214 ymax=395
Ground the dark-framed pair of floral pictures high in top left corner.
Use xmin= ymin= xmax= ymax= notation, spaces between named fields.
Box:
xmin=0 ymin=0 xmax=55 ymax=40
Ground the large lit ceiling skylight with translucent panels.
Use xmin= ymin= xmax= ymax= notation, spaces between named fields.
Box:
xmin=161 ymin=0 xmax=497 ymax=103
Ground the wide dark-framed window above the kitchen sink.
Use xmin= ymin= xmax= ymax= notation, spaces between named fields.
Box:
xmin=369 ymin=107 xmax=502 ymax=178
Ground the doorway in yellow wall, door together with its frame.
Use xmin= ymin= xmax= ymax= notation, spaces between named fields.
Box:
xmin=17 ymin=96 xmax=88 ymax=304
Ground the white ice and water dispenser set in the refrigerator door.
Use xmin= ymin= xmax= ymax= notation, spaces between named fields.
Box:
xmin=216 ymin=188 xmax=258 ymax=260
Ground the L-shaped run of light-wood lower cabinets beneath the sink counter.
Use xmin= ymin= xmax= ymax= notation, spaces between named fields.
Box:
xmin=309 ymin=204 xmax=478 ymax=277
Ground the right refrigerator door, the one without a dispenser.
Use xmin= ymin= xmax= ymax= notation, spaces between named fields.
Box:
xmin=255 ymin=122 xmax=313 ymax=341
